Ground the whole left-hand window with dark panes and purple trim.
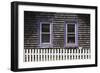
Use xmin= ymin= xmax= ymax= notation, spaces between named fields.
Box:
xmin=40 ymin=22 xmax=51 ymax=48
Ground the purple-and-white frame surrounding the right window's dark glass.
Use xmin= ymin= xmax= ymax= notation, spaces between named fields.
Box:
xmin=65 ymin=22 xmax=78 ymax=47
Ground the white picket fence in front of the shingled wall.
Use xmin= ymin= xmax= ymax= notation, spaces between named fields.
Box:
xmin=24 ymin=48 xmax=91 ymax=62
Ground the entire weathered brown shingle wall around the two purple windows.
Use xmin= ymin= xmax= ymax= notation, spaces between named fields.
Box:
xmin=24 ymin=11 xmax=90 ymax=49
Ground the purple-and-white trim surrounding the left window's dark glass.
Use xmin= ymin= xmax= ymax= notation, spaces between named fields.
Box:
xmin=40 ymin=22 xmax=53 ymax=48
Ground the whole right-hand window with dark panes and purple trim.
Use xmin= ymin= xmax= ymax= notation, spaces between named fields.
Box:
xmin=66 ymin=23 xmax=78 ymax=47
